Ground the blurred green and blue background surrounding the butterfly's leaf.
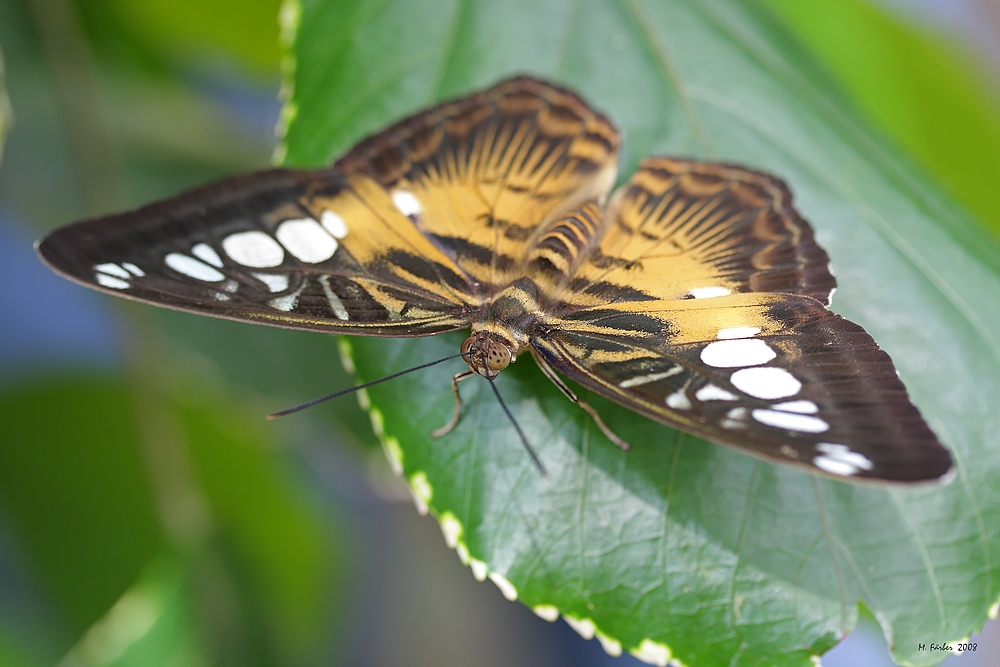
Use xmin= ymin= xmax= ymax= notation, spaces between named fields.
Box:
xmin=0 ymin=0 xmax=1000 ymax=667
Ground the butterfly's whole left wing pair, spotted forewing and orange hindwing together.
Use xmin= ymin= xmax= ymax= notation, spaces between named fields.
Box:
xmin=38 ymin=77 xmax=619 ymax=336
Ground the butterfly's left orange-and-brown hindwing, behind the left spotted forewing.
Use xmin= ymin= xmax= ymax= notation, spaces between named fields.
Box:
xmin=334 ymin=77 xmax=620 ymax=292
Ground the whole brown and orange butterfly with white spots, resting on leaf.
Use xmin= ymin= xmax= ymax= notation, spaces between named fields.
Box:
xmin=37 ymin=77 xmax=952 ymax=482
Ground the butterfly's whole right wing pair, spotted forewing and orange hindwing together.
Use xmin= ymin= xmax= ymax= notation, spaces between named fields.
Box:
xmin=531 ymin=158 xmax=951 ymax=481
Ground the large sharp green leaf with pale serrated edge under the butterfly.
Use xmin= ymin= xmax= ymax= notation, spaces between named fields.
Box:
xmin=283 ymin=0 xmax=1000 ymax=665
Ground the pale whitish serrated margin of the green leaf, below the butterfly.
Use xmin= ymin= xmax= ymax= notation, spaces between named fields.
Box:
xmin=336 ymin=340 xmax=686 ymax=667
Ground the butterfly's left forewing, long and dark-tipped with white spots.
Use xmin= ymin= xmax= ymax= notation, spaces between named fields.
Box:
xmin=38 ymin=169 xmax=480 ymax=336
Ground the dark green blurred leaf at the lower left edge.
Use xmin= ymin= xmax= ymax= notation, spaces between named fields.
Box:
xmin=0 ymin=377 xmax=163 ymax=632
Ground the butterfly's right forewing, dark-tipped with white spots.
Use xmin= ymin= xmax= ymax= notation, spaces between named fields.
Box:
xmin=532 ymin=293 xmax=951 ymax=482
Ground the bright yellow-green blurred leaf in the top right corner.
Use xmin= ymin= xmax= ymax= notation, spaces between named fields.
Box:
xmin=765 ymin=0 xmax=1000 ymax=237
